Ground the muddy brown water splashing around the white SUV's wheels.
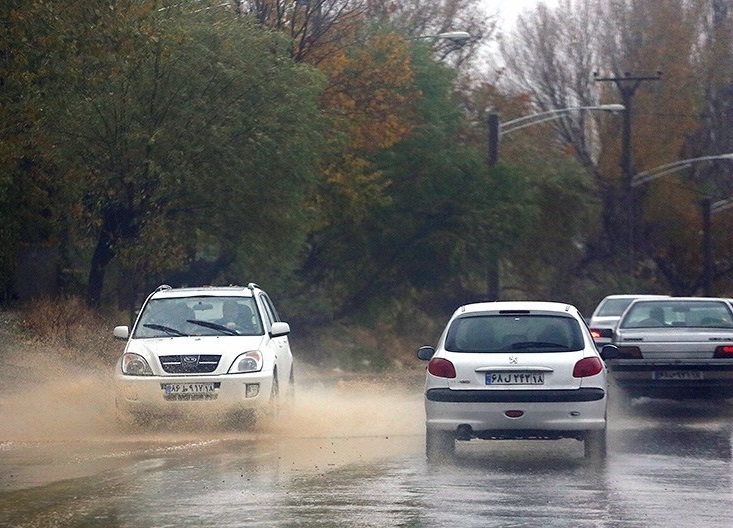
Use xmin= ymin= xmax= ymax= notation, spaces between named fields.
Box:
xmin=0 ymin=346 xmax=424 ymax=487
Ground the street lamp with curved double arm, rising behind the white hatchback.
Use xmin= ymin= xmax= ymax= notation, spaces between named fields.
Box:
xmin=486 ymin=104 xmax=625 ymax=301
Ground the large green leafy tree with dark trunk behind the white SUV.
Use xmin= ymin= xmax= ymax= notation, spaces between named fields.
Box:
xmin=30 ymin=1 xmax=321 ymax=303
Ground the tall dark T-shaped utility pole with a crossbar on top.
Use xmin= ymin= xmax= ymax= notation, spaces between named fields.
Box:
xmin=593 ymin=71 xmax=662 ymax=271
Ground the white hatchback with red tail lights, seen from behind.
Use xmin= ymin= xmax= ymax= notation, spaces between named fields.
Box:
xmin=418 ymin=301 xmax=607 ymax=460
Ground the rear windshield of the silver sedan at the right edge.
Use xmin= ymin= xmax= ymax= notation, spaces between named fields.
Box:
xmin=619 ymin=300 xmax=733 ymax=328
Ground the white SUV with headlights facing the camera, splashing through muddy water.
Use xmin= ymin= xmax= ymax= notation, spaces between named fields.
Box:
xmin=114 ymin=283 xmax=294 ymax=425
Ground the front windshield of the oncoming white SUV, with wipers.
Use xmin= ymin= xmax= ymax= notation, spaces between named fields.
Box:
xmin=133 ymin=296 xmax=263 ymax=338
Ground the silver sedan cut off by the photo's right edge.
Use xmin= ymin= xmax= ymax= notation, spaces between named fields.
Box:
xmin=603 ymin=297 xmax=733 ymax=400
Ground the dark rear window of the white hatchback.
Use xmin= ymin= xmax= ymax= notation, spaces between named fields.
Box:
xmin=445 ymin=314 xmax=584 ymax=352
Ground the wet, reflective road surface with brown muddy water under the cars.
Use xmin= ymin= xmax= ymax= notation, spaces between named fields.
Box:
xmin=0 ymin=385 xmax=733 ymax=528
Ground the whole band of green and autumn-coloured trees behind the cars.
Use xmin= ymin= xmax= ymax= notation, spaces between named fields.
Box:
xmin=0 ymin=0 xmax=733 ymax=369
